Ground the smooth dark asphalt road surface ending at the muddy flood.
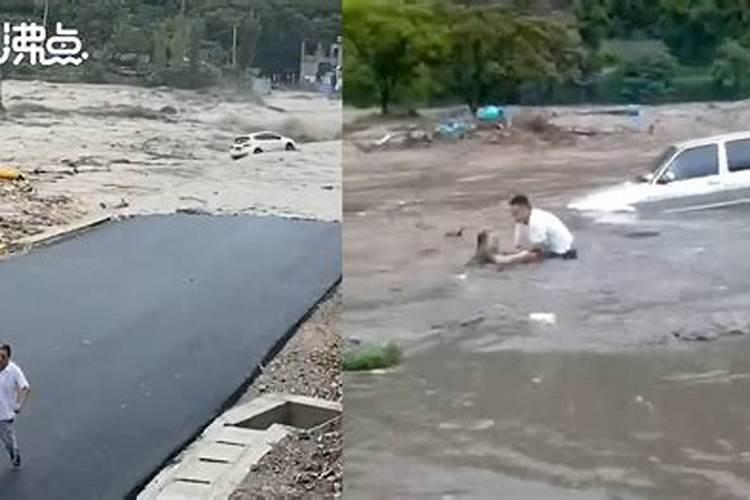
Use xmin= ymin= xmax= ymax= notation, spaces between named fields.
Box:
xmin=0 ymin=216 xmax=341 ymax=500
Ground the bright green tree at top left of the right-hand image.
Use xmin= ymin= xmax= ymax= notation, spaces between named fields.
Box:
xmin=344 ymin=0 xmax=443 ymax=114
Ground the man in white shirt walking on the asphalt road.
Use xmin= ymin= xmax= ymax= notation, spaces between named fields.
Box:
xmin=0 ymin=343 xmax=30 ymax=468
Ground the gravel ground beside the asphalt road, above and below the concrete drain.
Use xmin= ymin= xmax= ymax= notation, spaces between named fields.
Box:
xmin=230 ymin=291 xmax=343 ymax=500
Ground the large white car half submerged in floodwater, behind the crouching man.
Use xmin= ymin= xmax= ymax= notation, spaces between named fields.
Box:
xmin=568 ymin=132 xmax=750 ymax=212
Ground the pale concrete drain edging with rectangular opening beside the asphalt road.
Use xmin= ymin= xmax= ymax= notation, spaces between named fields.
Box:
xmin=137 ymin=394 xmax=343 ymax=500
